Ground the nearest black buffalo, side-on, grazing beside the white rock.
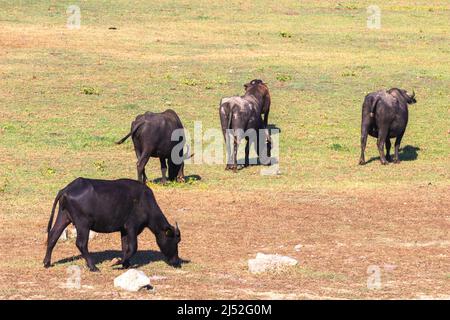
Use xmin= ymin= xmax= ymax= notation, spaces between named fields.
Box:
xmin=44 ymin=178 xmax=181 ymax=271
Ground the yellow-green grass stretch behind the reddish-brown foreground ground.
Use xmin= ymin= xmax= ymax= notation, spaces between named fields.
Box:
xmin=0 ymin=0 xmax=450 ymax=198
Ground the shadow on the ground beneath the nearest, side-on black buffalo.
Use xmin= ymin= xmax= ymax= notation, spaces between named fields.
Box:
xmin=54 ymin=250 xmax=190 ymax=268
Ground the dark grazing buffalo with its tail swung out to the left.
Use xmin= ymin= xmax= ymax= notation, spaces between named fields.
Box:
xmin=116 ymin=109 xmax=191 ymax=183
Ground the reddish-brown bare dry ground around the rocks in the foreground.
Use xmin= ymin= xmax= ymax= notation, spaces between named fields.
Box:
xmin=0 ymin=187 xmax=450 ymax=299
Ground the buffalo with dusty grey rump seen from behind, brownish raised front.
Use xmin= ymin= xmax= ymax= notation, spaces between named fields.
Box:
xmin=219 ymin=79 xmax=270 ymax=172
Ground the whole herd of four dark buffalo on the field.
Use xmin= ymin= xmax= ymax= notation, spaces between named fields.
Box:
xmin=44 ymin=79 xmax=416 ymax=271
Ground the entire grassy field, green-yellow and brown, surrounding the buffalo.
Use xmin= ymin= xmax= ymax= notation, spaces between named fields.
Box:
xmin=0 ymin=0 xmax=450 ymax=299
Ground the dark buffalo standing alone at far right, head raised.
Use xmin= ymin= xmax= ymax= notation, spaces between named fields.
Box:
xmin=359 ymin=88 xmax=416 ymax=165
